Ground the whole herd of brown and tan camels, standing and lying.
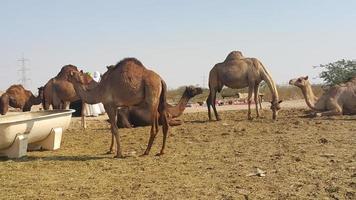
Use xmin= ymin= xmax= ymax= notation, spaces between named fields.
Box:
xmin=0 ymin=51 xmax=356 ymax=158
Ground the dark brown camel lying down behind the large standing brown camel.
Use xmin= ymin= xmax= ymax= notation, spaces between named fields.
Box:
xmin=117 ymin=86 xmax=203 ymax=128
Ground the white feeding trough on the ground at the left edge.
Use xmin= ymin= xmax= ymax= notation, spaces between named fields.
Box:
xmin=0 ymin=110 xmax=74 ymax=158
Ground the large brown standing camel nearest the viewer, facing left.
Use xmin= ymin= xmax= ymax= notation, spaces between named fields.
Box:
xmin=69 ymin=58 xmax=169 ymax=158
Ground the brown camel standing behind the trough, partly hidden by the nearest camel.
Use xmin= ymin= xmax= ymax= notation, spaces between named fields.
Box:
xmin=42 ymin=65 xmax=97 ymax=128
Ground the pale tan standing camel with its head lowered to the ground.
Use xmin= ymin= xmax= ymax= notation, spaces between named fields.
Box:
xmin=206 ymin=51 xmax=282 ymax=121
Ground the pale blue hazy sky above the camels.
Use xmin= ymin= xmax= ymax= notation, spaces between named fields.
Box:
xmin=0 ymin=0 xmax=356 ymax=90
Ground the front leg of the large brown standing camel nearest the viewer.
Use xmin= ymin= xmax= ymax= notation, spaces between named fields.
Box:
xmin=104 ymin=105 xmax=123 ymax=158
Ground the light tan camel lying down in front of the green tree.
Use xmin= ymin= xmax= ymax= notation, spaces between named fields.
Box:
xmin=289 ymin=76 xmax=356 ymax=117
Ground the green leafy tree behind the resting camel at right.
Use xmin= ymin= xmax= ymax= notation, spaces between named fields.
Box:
xmin=317 ymin=59 xmax=356 ymax=86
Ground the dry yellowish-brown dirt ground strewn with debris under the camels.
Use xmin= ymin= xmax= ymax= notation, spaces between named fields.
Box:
xmin=0 ymin=105 xmax=356 ymax=200
